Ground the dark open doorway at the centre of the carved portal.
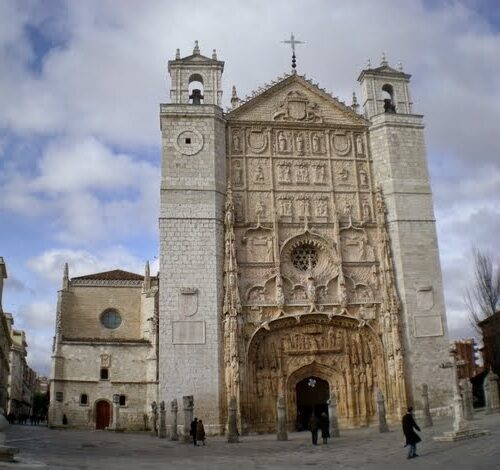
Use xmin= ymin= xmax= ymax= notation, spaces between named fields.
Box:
xmin=295 ymin=376 xmax=330 ymax=431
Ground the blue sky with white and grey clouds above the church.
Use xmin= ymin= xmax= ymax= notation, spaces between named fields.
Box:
xmin=0 ymin=0 xmax=500 ymax=374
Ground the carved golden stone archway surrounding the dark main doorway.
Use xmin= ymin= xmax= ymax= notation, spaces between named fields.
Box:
xmin=242 ymin=313 xmax=386 ymax=432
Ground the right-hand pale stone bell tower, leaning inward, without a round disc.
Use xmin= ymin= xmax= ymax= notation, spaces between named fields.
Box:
xmin=358 ymin=57 xmax=451 ymax=407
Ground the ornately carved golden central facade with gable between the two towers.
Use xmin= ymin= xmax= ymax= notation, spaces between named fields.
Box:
xmin=223 ymin=75 xmax=406 ymax=432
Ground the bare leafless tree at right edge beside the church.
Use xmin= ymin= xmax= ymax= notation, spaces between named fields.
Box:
xmin=464 ymin=247 xmax=500 ymax=332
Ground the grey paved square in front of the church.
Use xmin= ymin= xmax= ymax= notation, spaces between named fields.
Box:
xmin=0 ymin=412 xmax=500 ymax=470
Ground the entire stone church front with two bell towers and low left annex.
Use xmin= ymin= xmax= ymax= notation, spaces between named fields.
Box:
xmin=51 ymin=45 xmax=451 ymax=433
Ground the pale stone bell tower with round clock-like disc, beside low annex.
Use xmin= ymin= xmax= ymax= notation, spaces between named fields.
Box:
xmin=159 ymin=42 xmax=226 ymax=433
